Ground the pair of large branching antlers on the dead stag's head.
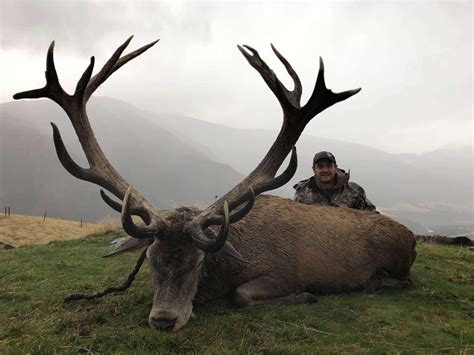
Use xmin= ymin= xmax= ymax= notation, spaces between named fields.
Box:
xmin=13 ymin=37 xmax=360 ymax=253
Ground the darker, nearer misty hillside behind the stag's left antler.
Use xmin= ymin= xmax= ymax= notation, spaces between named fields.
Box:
xmin=0 ymin=98 xmax=243 ymax=220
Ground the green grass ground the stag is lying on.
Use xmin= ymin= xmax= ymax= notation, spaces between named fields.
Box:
xmin=0 ymin=233 xmax=474 ymax=354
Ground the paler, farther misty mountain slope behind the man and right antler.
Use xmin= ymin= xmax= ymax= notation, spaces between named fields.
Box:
xmin=137 ymin=113 xmax=474 ymax=234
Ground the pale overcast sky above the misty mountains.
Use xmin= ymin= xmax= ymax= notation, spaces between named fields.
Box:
xmin=0 ymin=0 xmax=473 ymax=153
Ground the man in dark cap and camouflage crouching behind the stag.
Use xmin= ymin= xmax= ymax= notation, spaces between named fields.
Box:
xmin=293 ymin=151 xmax=375 ymax=212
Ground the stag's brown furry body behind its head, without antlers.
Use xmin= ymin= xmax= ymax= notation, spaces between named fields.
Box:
xmin=196 ymin=195 xmax=416 ymax=306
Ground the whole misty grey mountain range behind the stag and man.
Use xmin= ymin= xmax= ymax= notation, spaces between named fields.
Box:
xmin=0 ymin=97 xmax=474 ymax=234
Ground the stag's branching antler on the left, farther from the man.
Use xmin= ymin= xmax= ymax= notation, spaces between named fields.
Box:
xmin=13 ymin=36 xmax=169 ymax=238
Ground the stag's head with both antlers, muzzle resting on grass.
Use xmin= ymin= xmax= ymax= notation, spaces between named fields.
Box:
xmin=13 ymin=37 xmax=360 ymax=331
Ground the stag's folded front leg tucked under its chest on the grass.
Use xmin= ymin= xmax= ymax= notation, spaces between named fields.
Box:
xmin=235 ymin=276 xmax=316 ymax=307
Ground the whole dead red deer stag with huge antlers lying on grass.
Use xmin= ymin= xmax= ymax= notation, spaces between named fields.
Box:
xmin=14 ymin=37 xmax=416 ymax=331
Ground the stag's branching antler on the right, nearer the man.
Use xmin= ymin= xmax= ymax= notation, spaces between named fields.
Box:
xmin=187 ymin=45 xmax=361 ymax=251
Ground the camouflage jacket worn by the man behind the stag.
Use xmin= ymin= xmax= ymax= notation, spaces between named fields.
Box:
xmin=293 ymin=169 xmax=375 ymax=212
